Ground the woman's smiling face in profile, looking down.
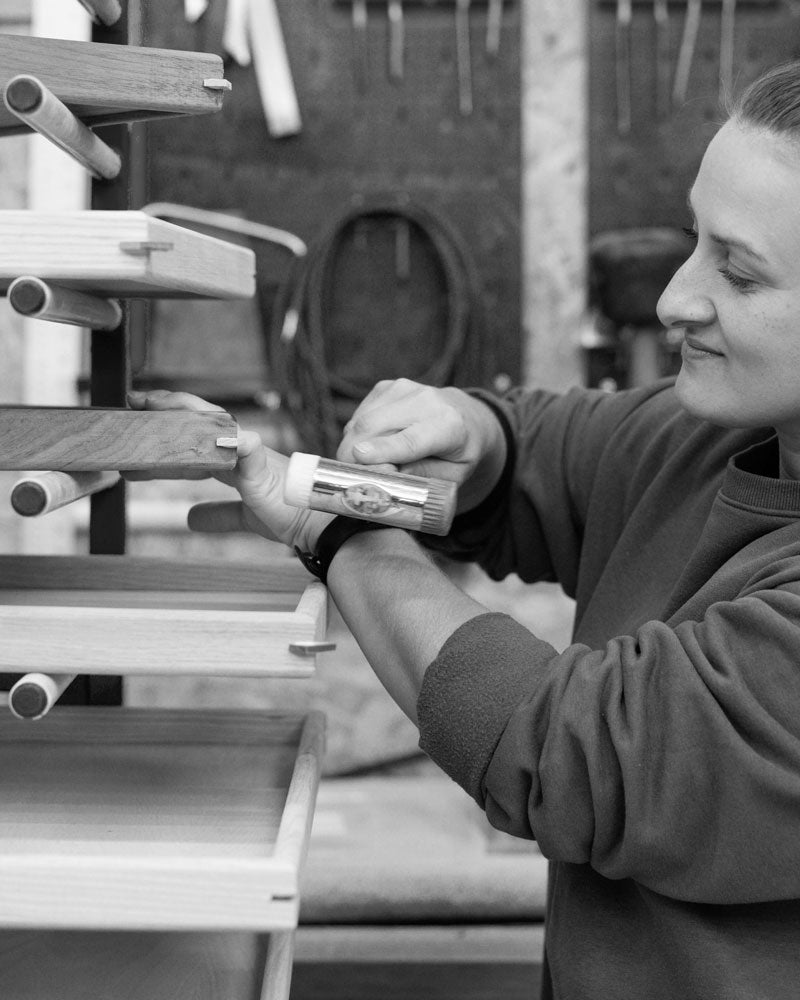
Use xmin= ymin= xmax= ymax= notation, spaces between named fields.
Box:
xmin=658 ymin=121 xmax=800 ymax=444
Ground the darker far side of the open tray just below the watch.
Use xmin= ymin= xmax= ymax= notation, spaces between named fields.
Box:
xmin=0 ymin=555 xmax=313 ymax=594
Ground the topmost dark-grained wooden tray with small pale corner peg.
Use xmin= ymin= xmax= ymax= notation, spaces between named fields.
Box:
xmin=0 ymin=35 xmax=224 ymax=135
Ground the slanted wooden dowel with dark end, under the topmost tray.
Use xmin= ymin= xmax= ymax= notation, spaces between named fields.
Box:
xmin=3 ymin=73 xmax=122 ymax=180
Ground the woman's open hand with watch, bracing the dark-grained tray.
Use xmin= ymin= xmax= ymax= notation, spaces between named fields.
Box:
xmin=126 ymin=390 xmax=332 ymax=552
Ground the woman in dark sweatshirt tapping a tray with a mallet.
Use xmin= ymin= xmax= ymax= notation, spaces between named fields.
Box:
xmin=134 ymin=64 xmax=800 ymax=1000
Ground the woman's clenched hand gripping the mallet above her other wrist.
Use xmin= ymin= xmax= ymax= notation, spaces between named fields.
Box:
xmin=337 ymin=379 xmax=506 ymax=511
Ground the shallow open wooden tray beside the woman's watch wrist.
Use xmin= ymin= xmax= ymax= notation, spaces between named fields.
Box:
xmin=0 ymin=555 xmax=327 ymax=680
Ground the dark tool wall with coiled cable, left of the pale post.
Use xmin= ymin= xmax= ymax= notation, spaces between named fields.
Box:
xmin=139 ymin=0 xmax=521 ymax=450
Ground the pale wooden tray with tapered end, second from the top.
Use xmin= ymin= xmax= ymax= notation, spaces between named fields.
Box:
xmin=0 ymin=210 xmax=255 ymax=299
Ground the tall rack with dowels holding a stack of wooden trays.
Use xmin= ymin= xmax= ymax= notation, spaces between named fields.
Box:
xmin=0 ymin=0 xmax=329 ymax=1000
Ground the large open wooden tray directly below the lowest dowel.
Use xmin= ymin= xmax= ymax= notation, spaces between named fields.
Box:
xmin=0 ymin=707 xmax=324 ymax=931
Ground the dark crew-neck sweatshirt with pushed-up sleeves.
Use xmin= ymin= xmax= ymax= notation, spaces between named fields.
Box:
xmin=418 ymin=381 xmax=800 ymax=1000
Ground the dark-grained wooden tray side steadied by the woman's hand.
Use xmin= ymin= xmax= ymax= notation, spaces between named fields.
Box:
xmin=0 ymin=406 xmax=238 ymax=472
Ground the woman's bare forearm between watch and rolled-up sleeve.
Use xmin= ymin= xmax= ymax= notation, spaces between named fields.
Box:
xmin=328 ymin=529 xmax=487 ymax=724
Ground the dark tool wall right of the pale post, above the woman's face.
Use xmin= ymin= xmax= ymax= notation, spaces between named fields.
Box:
xmin=589 ymin=0 xmax=800 ymax=234
